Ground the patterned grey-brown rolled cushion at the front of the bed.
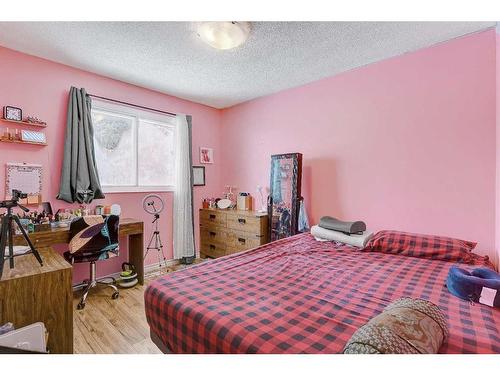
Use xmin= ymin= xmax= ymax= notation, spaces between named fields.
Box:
xmin=344 ymin=298 xmax=448 ymax=354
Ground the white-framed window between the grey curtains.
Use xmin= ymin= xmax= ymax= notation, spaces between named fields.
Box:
xmin=92 ymin=100 xmax=175 ymax=193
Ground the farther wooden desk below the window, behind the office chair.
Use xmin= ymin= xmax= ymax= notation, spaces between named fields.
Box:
xmin=11 ymin=219 xmax=144 ymax=285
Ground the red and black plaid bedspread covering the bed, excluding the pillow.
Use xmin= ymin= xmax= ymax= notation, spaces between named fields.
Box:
xmin=145 ymin=234 xmax=500 ymax=353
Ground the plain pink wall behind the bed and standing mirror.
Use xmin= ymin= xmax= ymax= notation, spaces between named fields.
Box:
xmin=221 ymin=30 xmax=495 ymax=262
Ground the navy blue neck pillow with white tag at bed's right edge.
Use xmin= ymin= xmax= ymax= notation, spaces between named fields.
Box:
xmin=446 ymin=266 xmax=500 ymax=307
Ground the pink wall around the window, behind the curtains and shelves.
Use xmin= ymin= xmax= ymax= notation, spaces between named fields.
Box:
xmin=0 ymin=47 xmax=221 ymax=282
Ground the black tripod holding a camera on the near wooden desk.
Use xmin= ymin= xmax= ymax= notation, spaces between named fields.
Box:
xmin=0 ymin=190 xmax=43 ymax=278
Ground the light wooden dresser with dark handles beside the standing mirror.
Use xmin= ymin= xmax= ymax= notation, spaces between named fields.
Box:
xmin=200 ymin=208 xmax=269 ymax=258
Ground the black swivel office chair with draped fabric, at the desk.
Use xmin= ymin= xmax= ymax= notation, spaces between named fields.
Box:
xmin=64 ymin=215 xmax=120 ymax=310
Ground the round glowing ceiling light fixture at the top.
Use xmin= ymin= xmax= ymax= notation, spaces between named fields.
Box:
xmin=198 ymin=21 xmax=250 ymax=49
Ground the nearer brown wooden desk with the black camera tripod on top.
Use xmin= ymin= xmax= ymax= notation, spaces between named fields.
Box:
xmin=0 ymin=247 xmax=73 ymax=354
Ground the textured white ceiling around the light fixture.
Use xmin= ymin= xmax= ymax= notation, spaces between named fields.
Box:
xmin=0 ymin=22 xmax=495 ymax=108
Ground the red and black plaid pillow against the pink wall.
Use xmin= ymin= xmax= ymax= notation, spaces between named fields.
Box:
xmin=363 ymin=230 xmax=476 ymax=263
